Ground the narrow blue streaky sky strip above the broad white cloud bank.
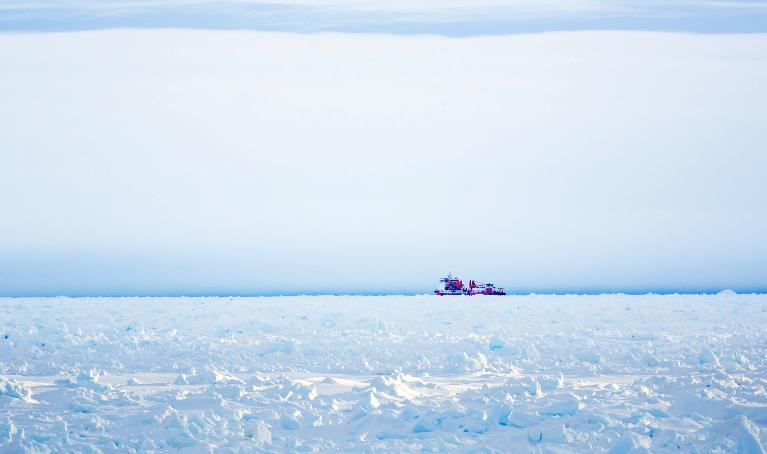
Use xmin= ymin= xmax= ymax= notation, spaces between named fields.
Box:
xmin=0 ymin=0 xmax=767 ymax=36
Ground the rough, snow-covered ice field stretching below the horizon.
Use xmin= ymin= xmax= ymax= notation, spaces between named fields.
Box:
xmin=0 ymin=292 xmax=767 ymax=453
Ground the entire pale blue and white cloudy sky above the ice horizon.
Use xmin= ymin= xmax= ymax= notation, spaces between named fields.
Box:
xmin=0 ymin=0 xmax=767 ymax=296
